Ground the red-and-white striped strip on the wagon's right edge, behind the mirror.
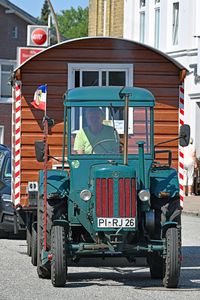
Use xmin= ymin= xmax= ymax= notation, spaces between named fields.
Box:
xmin=179 ymin=83 xmax=184 ymax=208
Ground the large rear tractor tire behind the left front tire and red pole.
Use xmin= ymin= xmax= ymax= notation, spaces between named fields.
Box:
xmin=37 ymin=197 xmax=52 ymax=279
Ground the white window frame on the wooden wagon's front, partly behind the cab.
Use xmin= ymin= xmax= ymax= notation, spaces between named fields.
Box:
xmin=68 ymin=63 xmax=133 ymax=133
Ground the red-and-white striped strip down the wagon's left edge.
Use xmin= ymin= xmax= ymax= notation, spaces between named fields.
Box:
xmin=14 ymin=82 xmax=21 ymax=206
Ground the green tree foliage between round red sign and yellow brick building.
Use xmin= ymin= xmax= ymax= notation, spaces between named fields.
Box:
xmin=57 ymin=6 xmax=88 ymax=39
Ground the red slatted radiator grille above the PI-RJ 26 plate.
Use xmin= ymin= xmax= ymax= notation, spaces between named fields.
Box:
xmin=96 ymin=178 xmax=136 ymax=218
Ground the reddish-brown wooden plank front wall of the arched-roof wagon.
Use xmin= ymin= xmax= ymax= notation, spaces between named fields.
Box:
xmin=14 ymin=38 xmax=180 ymax=202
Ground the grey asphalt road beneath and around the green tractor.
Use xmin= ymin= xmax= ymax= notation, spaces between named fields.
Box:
xmin=0 ymin=215 xmax=200 ymax=300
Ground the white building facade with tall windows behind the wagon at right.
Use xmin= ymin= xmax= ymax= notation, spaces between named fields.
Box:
xmin=123 ymin=0 xmax=200 ymax=158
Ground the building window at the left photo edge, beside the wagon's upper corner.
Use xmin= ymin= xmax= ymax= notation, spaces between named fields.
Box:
xmin=0 ymin=64 xmax=14 ymax=98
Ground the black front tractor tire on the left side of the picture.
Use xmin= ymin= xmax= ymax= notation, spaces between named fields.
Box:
xmin=51 ymin=225 xmax=67 ymax=287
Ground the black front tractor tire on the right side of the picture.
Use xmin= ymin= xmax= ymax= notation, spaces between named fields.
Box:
xmin=163 ymin=227 xmax=181 ymax=288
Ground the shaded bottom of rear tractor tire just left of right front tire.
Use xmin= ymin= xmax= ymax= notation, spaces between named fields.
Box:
xmin=147 ymin=253 xmax=164 ymax=279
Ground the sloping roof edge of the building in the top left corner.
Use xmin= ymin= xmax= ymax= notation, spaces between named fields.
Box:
xmin=0 ymin=0 xmax=41 ymax=25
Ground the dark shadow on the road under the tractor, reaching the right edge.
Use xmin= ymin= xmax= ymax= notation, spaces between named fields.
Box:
xmin=61 ymin=246 xmax=200 ymax=292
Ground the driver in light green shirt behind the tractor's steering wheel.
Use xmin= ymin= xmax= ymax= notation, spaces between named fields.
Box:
xmin=74 ymin=107 xmax=119 ymax=154
